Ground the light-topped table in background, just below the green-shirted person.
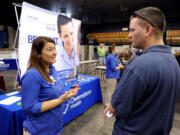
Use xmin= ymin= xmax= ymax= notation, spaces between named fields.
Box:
xmin=79 ymin=60 xmax=99 ymax=74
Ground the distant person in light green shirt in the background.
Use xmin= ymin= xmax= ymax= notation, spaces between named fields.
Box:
xmin=97 ymin=43 xmax=106 ymax=64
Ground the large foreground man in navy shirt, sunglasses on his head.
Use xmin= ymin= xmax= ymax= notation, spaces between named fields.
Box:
xmin=104 ymin=7 xmax=180 ymax=135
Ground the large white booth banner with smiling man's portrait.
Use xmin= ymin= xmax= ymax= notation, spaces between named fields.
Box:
xmin=18 ymin=2 xmax=81 ymax=77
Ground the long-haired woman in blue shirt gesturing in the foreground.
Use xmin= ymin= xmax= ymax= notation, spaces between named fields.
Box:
xmin=22 ymin=37 xmax=79 ymax=135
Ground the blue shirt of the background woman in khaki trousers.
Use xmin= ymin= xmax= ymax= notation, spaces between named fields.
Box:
xmin=106 ymin=53 xmax=120 ymax=79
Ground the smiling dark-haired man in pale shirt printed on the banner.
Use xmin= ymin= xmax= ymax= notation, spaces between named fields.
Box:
xmin=55 ymin=14 xmax=79 ymax=71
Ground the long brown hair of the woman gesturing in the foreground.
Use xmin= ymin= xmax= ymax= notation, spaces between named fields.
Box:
xmin=28 ymin=36 xmax=55 ymax=83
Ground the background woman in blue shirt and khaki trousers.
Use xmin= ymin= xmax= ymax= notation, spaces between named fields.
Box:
xmin=104 ymin=45 xmax=123 ymax=106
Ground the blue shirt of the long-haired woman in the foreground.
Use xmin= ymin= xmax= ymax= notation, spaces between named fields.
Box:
xmin=22 ymin=65 xmax=64 ymax=135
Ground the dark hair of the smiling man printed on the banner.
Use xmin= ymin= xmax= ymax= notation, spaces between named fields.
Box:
xmin=57 ymin=14 xmax=72 ymax=33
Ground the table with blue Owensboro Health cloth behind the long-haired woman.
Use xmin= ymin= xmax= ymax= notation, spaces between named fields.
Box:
xmin=0 ymin=75 xmax=102 ymax=135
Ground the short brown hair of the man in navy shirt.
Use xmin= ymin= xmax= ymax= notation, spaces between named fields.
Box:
xmin=130 ymin=7 xmax=166 ymax=33
